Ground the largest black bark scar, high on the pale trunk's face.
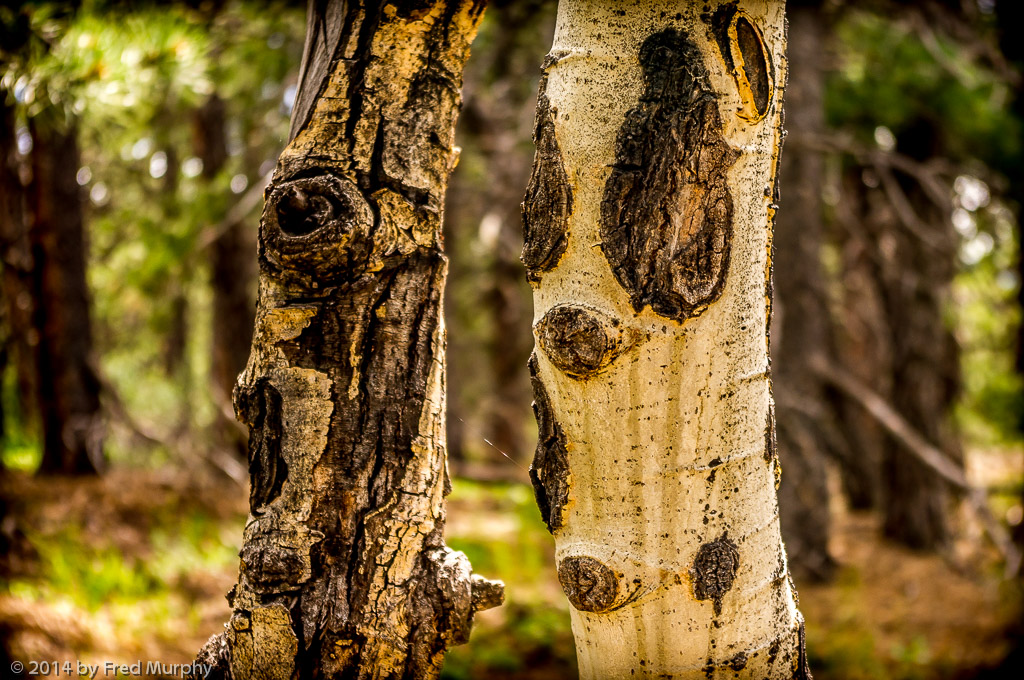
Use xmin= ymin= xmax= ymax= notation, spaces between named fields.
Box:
xmin=600 ymin=29 xmax=739 ymax=322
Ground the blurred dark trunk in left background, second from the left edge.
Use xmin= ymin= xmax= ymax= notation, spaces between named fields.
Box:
xmin=30 ymin=111 xmax=103 ymax=474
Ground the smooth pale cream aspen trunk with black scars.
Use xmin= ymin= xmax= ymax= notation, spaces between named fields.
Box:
xmin=523 ymin=0 xmax=808 ymax=679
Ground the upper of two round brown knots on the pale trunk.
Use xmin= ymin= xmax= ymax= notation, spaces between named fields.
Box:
xmin=534 ymin=304 xmax=635 ymax=378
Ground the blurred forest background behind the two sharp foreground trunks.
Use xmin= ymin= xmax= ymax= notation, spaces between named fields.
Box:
xmin=0 ymin=0 xmax=1024 ymax=679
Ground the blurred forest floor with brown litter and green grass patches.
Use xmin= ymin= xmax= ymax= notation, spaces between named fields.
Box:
xmin=0 ymin=450 xmax=1019 ymax=680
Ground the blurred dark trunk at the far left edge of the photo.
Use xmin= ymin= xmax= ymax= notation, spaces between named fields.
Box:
xmin=0 ymin=91 xmax=36 ymax=440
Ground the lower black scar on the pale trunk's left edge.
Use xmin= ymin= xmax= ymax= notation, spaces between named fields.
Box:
xmin=529 ymin=354 xmax=569 ymax=534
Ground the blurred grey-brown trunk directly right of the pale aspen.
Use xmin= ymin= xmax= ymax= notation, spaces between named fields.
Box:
xmin=771 ymin=2 xmax=834 ymax=580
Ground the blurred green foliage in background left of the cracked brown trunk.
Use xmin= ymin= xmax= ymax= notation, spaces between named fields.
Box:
xmin=3 ymin=2 xmax=305 ymax=462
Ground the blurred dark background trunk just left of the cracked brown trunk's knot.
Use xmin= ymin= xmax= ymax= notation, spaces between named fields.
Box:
xmin=194 ymin=94 xmax=256 ymax=457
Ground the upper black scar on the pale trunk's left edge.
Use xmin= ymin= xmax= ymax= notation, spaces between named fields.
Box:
xmin=520 ymin=75 xmax=572 ymax=281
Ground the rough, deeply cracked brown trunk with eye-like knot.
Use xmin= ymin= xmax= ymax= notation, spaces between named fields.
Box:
xmin=198 ymin=0 xmax=502 ymax=680
